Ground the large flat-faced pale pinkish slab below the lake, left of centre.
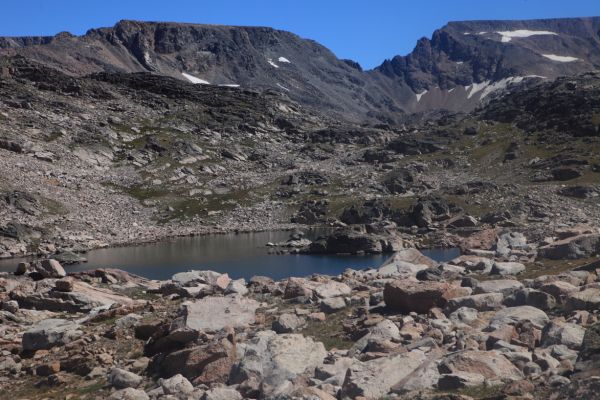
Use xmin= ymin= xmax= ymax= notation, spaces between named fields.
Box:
xmin=181 ymin=297 xmax=259 ymax=332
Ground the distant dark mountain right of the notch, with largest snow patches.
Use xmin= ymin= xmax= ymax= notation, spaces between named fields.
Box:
xmin=376 ymin=17 xmax=600 ymax=110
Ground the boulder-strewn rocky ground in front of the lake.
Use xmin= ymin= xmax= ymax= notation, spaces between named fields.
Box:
xmin=0 ymin=227 xmax=600 ymax=400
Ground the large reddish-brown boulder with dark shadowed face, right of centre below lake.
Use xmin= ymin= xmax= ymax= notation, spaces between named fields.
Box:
xmin=383 ymin=280 xmax=470 ymax=313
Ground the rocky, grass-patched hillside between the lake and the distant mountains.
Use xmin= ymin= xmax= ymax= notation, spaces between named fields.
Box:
xmin=0 ymin=57 xmax=600 ymax=258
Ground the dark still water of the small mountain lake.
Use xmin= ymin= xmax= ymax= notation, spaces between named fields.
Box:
xmin=0 ymin=231 xmax=459 ymax=279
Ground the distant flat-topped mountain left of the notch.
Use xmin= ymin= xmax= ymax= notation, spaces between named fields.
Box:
xmin=0 ymin=21 xmax=408 ymax=120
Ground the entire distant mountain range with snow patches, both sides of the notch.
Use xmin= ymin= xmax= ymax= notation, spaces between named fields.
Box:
xmin=0 ymin=18 xmax=600 ymax=122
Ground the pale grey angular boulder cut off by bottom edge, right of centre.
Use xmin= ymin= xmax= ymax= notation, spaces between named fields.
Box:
xmin=340 ymin=350 xmax=437 ymax=399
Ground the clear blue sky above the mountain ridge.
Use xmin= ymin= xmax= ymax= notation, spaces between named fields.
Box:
xmin=0 ymin=0 xmax=600 ymax=68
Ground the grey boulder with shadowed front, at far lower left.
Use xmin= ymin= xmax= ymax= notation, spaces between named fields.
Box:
xmin=22 ymin=319 xmax=83 ymax=351
